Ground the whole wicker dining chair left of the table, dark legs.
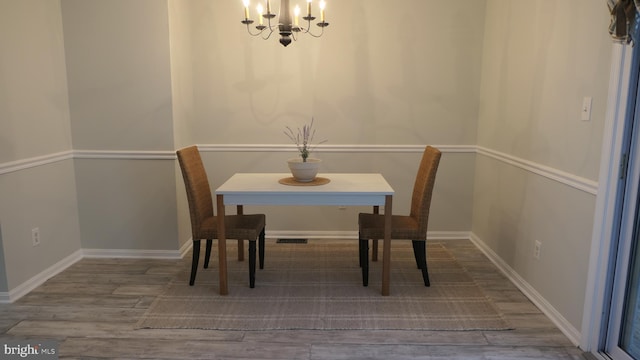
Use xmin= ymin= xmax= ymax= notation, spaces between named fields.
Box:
xmin=176 ymin=146 xmax=266 ymax=288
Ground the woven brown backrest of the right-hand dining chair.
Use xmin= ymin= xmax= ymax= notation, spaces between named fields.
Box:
xmin=409 ymin=146 xmax=442 ymax=236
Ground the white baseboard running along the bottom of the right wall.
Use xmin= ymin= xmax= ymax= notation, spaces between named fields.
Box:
xmin=469 ymin=233 xmax=582 ymax=346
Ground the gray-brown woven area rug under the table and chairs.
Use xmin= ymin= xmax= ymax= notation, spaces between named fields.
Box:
xmin=137 ymin=240 xmax=510 ymax=330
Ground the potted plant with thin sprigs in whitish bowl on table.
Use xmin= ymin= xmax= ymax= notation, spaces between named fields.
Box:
xmin=284 ymin=118 xmax=327 ymax=182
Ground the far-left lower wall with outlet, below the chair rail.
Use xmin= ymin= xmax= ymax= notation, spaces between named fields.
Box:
xmin=0 ymin=160 xmax=81 ymax=290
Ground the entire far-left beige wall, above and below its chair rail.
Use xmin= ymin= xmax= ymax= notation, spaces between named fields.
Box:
xmin=0 ymin=0 xmax=80 ymax=292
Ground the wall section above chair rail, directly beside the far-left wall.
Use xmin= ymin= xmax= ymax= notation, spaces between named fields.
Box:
xmin=61 ymin=0 xmax=173 ymax=150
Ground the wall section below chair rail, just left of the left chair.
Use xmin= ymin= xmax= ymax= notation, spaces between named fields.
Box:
xmin=75 ymin=159 xmax=178 ymax=250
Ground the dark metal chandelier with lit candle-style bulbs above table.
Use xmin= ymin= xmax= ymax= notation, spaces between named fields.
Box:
xmin=242 ymin=0 xmax=329 ymax=46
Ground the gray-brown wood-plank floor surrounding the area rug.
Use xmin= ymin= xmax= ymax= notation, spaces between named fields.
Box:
xmin=0 ymin=240 xmax=584 ymax=360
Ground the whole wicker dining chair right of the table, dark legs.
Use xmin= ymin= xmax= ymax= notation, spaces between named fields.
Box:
xmin=358 ymin=146 xmax=442 ymax=286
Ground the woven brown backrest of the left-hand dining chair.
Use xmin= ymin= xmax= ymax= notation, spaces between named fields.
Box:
xmin=176 ymin=146 xmax=213 ymax=235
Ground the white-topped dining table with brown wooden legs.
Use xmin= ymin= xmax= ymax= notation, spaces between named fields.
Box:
xmin=215 ymin=173 xmax=394 ymax=296
